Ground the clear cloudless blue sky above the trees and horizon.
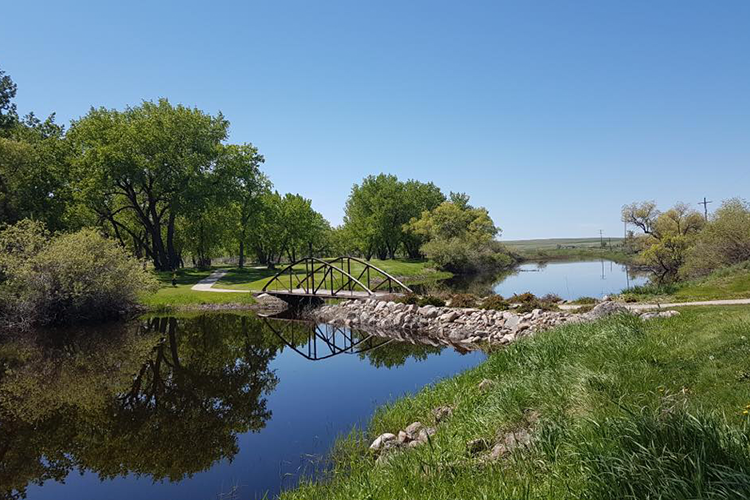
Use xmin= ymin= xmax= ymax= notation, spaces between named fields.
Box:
xmin=0 ymin=0 xmax=750 ymax=239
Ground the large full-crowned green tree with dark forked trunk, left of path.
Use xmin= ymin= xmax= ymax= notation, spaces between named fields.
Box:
xmin=68 ymin=99 xmax=229 ymax=270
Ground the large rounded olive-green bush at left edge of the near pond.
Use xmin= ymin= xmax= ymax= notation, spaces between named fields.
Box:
xmin=0 ymin=223 xmax=158 ymax=327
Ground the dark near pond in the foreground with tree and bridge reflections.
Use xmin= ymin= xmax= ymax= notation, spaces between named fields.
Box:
xmin=0 ymin=314 xmax=484 ymax=500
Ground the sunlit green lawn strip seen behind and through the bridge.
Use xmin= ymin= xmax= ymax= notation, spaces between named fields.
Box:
xmin=216 ymin=259 xmax=452 ymax=290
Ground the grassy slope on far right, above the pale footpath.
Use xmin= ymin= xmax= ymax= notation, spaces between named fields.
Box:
xmin=621 ymin=262 xmax=750 ymax=302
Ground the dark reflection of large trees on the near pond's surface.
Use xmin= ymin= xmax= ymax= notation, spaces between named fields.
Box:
xmin=0 ymin=315 xmax=279 ymax=498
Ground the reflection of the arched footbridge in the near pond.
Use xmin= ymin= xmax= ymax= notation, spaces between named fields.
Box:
xmin=264 ymin=318 xmax=394 ymax=361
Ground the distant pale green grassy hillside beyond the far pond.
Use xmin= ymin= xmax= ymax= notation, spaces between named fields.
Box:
xmin=503 ymin=238 xmax=634 ymax=263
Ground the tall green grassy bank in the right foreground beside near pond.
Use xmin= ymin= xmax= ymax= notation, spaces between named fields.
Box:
xmin=282 ymin=307 xmax=750 ymax=500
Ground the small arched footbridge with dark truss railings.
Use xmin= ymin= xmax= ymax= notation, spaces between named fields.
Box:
xmin=263 ymin=256 xmax=412 ymax=299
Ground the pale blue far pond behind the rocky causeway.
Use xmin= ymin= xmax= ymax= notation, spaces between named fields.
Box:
xmin=447 ymin=260 xmax=648 ymax=300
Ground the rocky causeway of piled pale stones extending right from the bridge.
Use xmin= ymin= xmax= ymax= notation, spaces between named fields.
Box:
xmin=308 ymin=299 xmax=679 ymax=348
